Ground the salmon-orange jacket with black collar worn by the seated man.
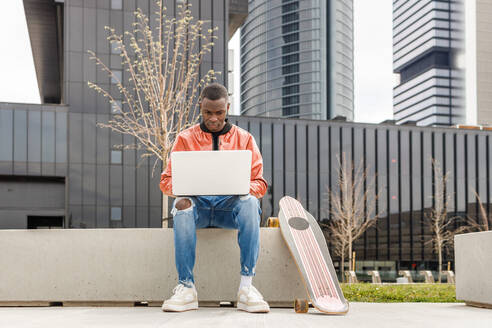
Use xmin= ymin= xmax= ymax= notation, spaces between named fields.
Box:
xmin=160 ymin=122 xmax=267 ymax=198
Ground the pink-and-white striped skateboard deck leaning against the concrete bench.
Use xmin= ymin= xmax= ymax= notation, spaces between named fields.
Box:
xmin=278 ymin=196 xmax=349 ymax=314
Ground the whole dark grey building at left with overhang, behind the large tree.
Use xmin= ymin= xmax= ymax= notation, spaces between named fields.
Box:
xmin=0 ymin=0 xmax=238 ymax=229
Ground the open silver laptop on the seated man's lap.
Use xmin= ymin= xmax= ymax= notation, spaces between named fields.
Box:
xmin=171 ymin=150 xmax=251 ymax=196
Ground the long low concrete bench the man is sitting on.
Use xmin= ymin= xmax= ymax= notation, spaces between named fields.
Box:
xmin=0 ymin=228 xmax=307 ymax=307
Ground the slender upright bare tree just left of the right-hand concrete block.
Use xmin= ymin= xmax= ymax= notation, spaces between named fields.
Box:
xmin=425 ymin=159 xmax=455 ymax=282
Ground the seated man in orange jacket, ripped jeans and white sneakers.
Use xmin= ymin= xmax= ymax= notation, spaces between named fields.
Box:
xmin=160 ymin=83 xmax=270 ymax=312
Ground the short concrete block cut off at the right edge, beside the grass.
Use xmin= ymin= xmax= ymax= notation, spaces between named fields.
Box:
xmin=454 ymin=231 xmax=492 ymax=307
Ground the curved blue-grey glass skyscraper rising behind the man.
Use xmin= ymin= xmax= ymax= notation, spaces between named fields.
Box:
xmin=241 ymin=0 xmax=354 ymax=120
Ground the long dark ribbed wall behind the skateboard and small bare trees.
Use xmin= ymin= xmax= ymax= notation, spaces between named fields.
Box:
xmin=231 ymin=117 xmax=492 ymax=262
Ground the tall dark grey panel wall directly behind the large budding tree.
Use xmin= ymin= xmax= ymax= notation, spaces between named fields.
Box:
xmin=63 ymin=0 xmax=228 ymax=228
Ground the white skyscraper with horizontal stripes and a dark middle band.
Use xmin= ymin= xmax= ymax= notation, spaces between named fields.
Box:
xmin=393 ymin=0 xmax=465 ymax=126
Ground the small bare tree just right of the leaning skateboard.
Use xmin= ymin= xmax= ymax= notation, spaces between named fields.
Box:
xmin=323 ymin=153 xmax=379 ymax=280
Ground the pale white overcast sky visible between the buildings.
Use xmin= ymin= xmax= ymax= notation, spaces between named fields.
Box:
xmin=0 ymin=0 xmax=394 ymax=123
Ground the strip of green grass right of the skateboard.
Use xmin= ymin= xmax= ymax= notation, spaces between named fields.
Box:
xmin=341 ymin=283 xmax=460 ymax=303
